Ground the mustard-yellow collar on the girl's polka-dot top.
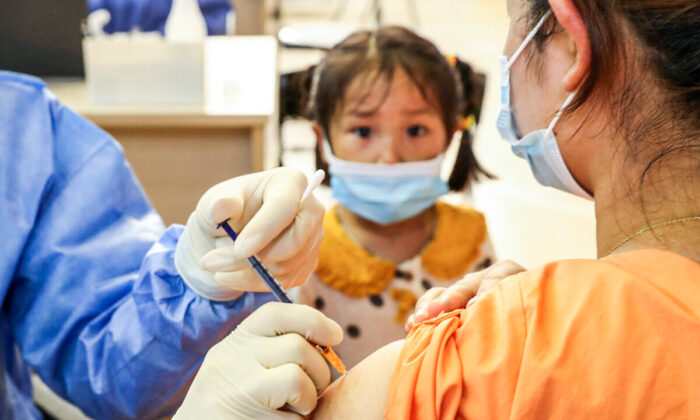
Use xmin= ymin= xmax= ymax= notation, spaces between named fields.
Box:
xmin=316 ymin=202 xmax=486 ymax=298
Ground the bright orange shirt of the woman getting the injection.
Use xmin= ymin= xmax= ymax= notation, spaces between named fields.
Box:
xmin=386 ymin=250 xmax=700 ymax=420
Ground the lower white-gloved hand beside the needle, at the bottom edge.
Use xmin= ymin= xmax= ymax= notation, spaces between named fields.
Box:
xmin=174 ymin=302 xmax=343 ymax=420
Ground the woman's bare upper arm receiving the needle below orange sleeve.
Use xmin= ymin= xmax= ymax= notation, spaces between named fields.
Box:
xmin=311 ymin=340 xmax=403 ymax=420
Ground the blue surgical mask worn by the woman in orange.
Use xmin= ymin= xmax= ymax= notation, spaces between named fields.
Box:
xmin=496 ymin=10 xmax=592 ymax=199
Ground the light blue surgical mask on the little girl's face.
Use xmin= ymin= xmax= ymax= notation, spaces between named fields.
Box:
xmin=323 ymin=141 xmax=449 ymax=225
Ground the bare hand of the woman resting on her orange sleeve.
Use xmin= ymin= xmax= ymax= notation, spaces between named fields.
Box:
xmin=405 ymin=260 xmax=525 ymax=333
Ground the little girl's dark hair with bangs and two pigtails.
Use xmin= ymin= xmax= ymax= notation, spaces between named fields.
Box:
xmin=285 ymin=26 xmax=491 ymax=191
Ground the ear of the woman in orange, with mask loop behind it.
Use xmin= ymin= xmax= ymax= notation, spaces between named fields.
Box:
xmin=549 ymin=0 xmax=591 ymax=92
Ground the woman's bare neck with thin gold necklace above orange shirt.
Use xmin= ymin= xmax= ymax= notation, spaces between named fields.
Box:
xmin=595 ymin=158 xmax=700 ymax=262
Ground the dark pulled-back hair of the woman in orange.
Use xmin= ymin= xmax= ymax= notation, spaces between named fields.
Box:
xmin=527 ymin=0 xmax=700 ymax=199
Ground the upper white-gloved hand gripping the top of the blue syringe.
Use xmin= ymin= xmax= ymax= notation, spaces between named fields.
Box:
xmin=175 ymin=168 xmax=325 ymax=301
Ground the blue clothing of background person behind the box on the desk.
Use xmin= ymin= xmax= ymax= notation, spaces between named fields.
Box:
xmin=87 ymin=0 xmax=232 ymax=35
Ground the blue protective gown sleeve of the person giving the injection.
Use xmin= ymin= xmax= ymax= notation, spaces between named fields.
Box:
xmin=0 ymin=72 xmax=271 ymax=419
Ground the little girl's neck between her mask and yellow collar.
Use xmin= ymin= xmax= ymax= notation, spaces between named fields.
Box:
xmin=336 ymin=205 xmax=438 ymax=264
